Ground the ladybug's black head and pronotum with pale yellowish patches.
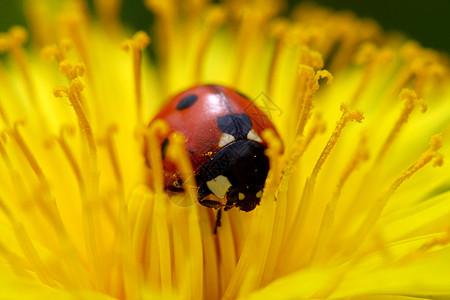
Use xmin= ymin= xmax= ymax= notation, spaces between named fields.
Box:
xmin=197 ymin=140 xmax=269 ymax=211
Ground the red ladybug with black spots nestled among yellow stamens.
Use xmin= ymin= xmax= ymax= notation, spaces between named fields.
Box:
xmin=146 ymin=85 xmax=282 ymax=233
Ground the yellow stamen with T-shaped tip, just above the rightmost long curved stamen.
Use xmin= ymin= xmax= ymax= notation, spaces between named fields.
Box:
xmin=375 ymin=89 xmax=426 ymax=165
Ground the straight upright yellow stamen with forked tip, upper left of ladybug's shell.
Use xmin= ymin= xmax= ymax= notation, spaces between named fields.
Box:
xmin=122 ymin=30 xmax=150 ymax=125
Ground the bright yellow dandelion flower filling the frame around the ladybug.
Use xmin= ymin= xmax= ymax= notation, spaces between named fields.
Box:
xmin=0 ymin=0 xmax=450 ymax=299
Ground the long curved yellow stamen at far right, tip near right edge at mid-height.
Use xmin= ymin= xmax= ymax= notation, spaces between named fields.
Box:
xmin=345 ymin=135 xmax=443 ymax=254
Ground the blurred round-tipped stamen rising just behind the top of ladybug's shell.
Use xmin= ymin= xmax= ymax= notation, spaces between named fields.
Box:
xmin=194 ymin=5 xmax=225 ymax=83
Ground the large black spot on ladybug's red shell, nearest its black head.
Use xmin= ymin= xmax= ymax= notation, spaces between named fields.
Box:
xmin=217 ymin=114 xmax=253 ymax=140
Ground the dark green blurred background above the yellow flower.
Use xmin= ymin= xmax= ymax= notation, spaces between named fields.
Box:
xmin=0 ymin=0 xmax=450 ymax=53
